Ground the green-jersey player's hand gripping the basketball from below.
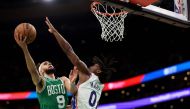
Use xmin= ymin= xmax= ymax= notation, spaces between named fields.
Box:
xmin=14 ymin=33 xmax=27 ymax=49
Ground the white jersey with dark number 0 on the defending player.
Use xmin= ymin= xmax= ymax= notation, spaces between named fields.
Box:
xmin=72 ymin=73 xmax=104 ymax=109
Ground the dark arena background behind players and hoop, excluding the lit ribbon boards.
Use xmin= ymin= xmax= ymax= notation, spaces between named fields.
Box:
xmin=0 ymin=0 xmax=190 ymax=109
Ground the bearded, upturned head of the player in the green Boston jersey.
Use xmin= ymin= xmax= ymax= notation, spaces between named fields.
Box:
xmin=38 ymin=61 xmax=56 ymax=78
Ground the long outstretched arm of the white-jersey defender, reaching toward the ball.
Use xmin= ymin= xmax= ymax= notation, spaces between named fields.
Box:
xmin=45 ymin=17 xmax=90 ymax=76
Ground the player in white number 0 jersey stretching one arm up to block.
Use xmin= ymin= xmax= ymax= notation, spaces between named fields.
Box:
xmin=45 ymin=17 xmax=104 ymax=109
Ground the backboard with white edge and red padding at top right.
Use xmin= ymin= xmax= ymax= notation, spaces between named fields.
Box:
xmin=96 ymin=0 xmax=190 ymax=28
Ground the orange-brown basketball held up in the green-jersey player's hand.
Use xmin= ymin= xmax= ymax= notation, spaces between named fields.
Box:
xmin=14 ymin=23 xmax=36 ymax=44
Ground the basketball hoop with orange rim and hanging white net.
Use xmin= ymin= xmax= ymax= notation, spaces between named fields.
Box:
xmin=91 ymin=2 xmax=127 ymax=42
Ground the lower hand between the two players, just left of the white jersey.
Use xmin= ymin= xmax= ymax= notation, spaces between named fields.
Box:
xmin=69 ymin=66 xmax=78 ymax=83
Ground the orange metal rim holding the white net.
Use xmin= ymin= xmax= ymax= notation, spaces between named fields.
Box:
xmin=91 ymin=1 xmax=128 ymax=16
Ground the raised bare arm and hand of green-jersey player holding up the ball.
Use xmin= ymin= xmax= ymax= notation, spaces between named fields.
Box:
xmin=15 ymin=33 xmax=43 ymax=90
